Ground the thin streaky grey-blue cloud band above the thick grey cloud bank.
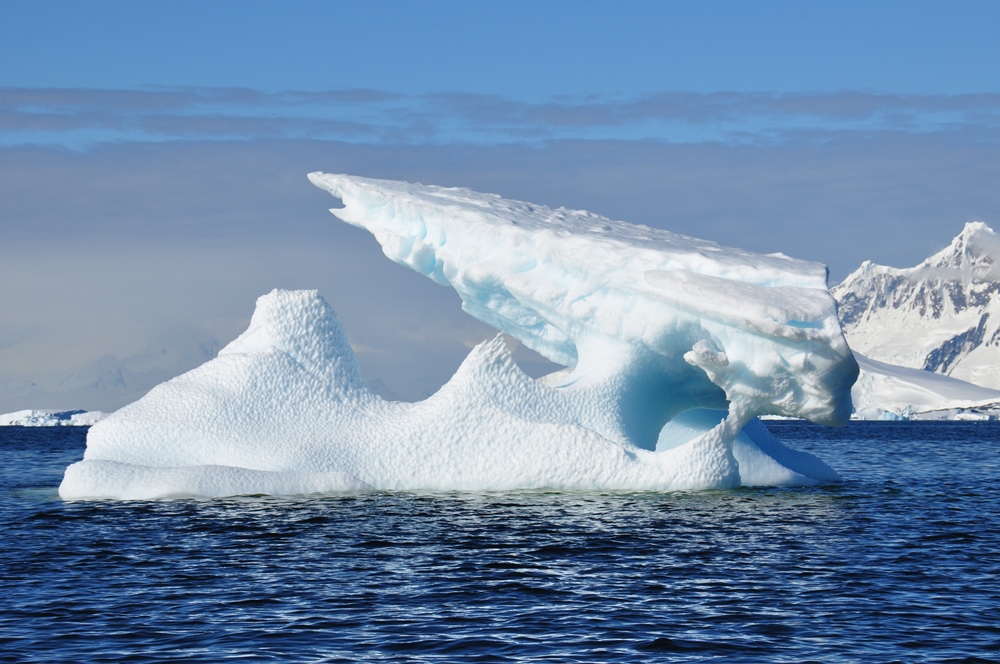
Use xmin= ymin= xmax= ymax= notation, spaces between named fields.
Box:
xmin=0 ymin=88 xmax=1000 ymax=147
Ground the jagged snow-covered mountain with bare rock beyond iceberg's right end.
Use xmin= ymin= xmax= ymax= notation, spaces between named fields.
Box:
xmin=832 ymin=222 xmax=1000 ymax=389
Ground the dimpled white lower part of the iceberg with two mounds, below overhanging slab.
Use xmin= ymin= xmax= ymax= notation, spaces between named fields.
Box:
xmin=59 ymin=290 xmax=838 ymax=499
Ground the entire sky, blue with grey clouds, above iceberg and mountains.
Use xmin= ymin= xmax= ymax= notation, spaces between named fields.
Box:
xmin=0 ymin=0 xmax=1000 ymax=412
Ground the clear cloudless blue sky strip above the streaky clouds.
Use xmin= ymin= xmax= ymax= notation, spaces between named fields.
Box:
xmin=0 ymin=0 xmax=1000 ymax=94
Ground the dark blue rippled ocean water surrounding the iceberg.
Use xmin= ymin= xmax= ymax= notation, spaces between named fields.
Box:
xmin=0 ymin=422 xmax=1000 ymax=662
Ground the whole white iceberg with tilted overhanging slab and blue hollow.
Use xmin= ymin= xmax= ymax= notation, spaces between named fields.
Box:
xmin=59 ymin=173 xmax=858 ymax=499
